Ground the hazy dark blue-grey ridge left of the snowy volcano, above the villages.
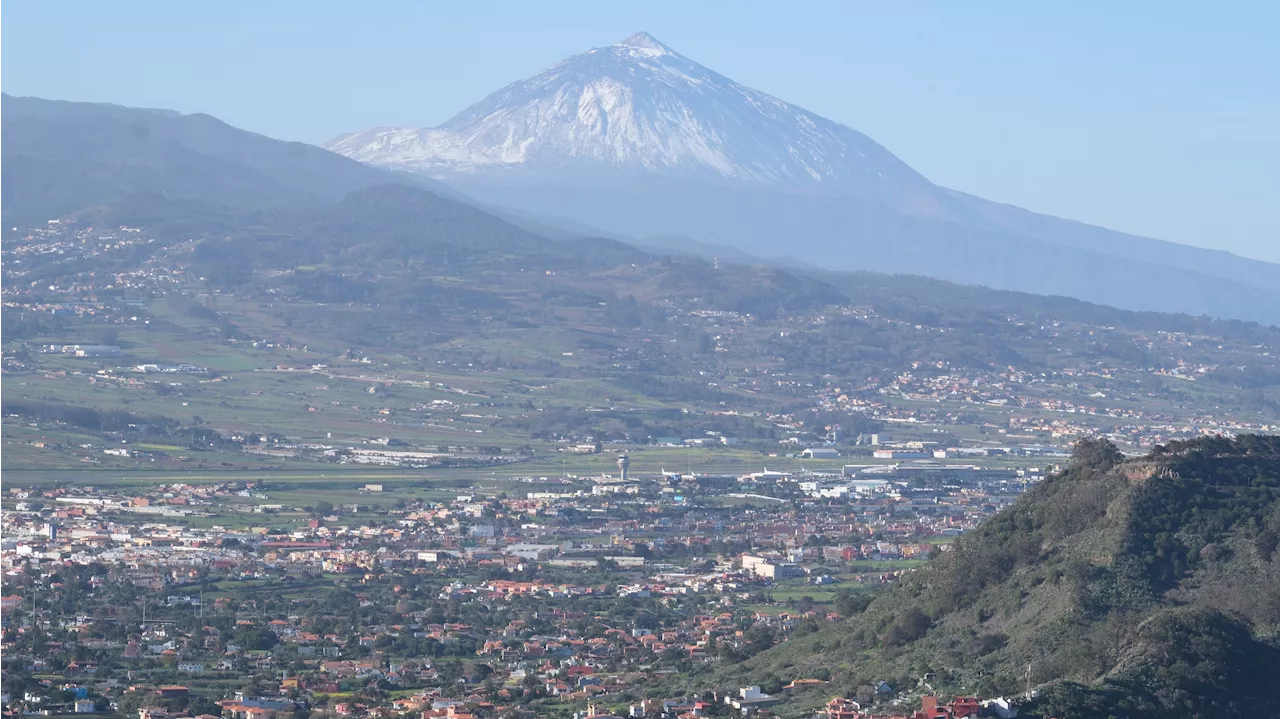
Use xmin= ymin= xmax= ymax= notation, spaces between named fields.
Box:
xmin=0 ymin=95 xmax=450 ymax=223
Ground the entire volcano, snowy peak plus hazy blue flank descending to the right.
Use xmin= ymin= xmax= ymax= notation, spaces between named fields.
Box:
xmin=326 ymin=33 xmax=1280 ymax=322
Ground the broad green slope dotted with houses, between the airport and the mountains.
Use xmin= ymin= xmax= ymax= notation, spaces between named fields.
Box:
xmin=0 ymin=194 xmax=1277 ymax=470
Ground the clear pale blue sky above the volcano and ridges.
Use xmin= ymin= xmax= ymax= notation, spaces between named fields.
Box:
xmin=0 ymin=0 xmax=1280 ymax=261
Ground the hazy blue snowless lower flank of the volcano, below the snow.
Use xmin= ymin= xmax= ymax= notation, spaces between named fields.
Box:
xmin=454 ymin=178 xmax=1280 ymax=324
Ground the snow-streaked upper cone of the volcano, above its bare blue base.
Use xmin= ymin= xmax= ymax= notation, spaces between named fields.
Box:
xmin=325 ymin=32 xmax=932 ymax=196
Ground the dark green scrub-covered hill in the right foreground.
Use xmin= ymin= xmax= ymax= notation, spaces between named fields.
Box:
xmin=724 ymin=435 xmax=1280 ymax=719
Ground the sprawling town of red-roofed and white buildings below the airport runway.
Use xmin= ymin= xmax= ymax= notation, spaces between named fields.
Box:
xmin=0 ymin=455 xmax=1041 ymax=719
